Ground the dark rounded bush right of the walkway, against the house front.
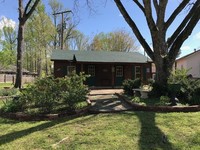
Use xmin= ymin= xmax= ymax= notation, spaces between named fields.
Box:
xmin=122 ymin=78 xmax=141 ymax=95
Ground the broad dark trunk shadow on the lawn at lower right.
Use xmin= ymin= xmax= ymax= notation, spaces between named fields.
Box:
xmin=136 ymin=112 xmax=174 ymax=150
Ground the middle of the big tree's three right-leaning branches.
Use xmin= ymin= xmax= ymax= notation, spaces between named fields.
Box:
xmin=167 ymin=1 xmax=200 ymax=47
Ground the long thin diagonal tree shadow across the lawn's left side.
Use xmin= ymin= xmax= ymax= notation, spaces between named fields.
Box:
xmin=0 ymin=114 xmax=96 ymax=145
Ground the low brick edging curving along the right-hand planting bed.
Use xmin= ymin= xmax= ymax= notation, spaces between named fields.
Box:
xmin=116 ymin=94 xmax=200 ymax=112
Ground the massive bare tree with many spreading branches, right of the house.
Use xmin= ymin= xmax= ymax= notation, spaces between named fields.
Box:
xmin=114 ymin=0 xmax=200 ymax=86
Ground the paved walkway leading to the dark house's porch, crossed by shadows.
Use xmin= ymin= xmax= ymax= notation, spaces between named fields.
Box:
xmin=89 ymin=89 xmax=132 ymax=113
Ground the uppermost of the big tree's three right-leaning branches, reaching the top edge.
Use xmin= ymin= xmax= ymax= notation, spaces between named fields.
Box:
xmin=165 ymin=0 xmax=190 ymax=29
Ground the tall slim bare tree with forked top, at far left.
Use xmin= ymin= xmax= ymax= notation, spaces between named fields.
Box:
xmin=14 ymin=0 xmax=40 ymax=88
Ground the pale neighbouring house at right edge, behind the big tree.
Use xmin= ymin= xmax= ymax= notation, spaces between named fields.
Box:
xmin=175 ymin=50 xmax=200 ymax=78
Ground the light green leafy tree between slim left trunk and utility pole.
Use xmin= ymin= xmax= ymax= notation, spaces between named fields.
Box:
xmin=25 ymin=3 xmax=55 ymax=76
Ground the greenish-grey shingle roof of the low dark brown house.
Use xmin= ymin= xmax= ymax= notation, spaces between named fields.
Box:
xmin=51 ymin=50 xmax=147 ymax=63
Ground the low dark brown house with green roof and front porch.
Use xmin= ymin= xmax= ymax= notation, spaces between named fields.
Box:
xmin=51 ymin=50 xmax=152 ymax=87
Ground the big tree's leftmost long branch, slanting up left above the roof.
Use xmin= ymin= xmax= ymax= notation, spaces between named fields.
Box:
xmin=114 ymin=0 xmax=154 ymax=60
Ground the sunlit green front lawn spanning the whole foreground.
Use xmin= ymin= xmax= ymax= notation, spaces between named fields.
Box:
xmin=0 ymin=112 xmax=200 ymax=150
